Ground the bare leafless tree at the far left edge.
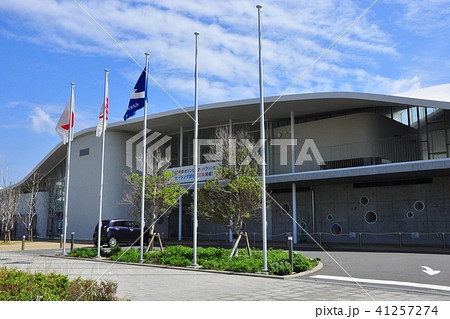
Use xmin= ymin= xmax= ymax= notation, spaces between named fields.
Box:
xmin=0 ymin=185 xmax=19 ymax=243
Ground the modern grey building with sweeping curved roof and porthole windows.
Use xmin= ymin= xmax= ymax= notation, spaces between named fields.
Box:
xmin=6 ymin=86 xmax=450 ymax=245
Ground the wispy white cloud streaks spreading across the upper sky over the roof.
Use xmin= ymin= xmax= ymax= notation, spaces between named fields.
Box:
xmin=0 ymin=0 xmax=448 ymax=104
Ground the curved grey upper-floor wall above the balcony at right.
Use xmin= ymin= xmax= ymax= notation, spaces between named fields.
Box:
xmin=272 ymin=113 xmax=416 ymax=174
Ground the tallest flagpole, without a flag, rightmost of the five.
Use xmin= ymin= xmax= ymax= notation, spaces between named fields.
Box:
xmin=256 ymin=5 xmax=269 ymax=273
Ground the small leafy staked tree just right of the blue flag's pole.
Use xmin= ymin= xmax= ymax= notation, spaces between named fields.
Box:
xmin=122 ymin=156 xmax=186 ymax=234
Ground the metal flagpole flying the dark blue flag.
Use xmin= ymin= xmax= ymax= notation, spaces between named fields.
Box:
xmin=139 ymin=52 xmax=150 ymax=263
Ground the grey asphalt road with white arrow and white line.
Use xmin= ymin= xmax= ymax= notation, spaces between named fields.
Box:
xmin=296 ymin=251 xmax=450 ymax=299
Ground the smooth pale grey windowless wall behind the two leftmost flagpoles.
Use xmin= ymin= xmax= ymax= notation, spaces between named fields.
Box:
xmin=67 ymin=132 xmax=131 ymax=240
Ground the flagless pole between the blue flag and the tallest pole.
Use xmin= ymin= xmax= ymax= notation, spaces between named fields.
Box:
xmin=192 ymin=32 xmax=200 ymax=267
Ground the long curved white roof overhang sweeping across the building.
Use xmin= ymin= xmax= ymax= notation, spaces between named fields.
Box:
xmin=12 ymin=90 xmax=450 ymax=189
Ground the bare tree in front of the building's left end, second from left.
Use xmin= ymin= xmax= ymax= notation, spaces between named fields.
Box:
xmin=19 ymin=172 xmax=43 ymax=241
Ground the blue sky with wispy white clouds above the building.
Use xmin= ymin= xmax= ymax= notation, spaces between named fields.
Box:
xmin=0 ymin=0 xmax=450 ymax=186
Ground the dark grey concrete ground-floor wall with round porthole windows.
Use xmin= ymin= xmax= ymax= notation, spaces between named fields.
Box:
xmin=272 ymin=177 xmax=450 ymax=245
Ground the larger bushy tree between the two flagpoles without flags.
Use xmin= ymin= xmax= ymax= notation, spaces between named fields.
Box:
xmin=197 ymin=129 xmax=268 ymax=255
